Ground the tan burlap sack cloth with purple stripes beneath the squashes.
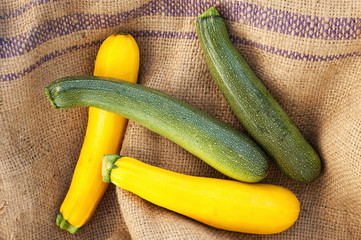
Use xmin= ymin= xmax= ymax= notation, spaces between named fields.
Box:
xmin=0 ymin=0 xmax=361 ymax=239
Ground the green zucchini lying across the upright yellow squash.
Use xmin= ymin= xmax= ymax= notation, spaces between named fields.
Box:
xmin=45 ymin=77 xmax=269 ymax=182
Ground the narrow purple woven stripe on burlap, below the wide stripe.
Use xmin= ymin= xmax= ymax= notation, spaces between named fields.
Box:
xmin=0 ymin=31 xmax=361 ymax=82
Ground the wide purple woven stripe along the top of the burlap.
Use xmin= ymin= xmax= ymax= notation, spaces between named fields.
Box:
xmin=0 ymin=0 xmax=361 ymax=58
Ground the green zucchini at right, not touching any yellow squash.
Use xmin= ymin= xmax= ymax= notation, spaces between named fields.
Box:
xmin=196 ymin=7 xmax=321 ymax=183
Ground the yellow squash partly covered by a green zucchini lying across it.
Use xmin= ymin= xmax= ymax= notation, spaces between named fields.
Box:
xmin=56 ymin=34 xmax=139 ymax=233
